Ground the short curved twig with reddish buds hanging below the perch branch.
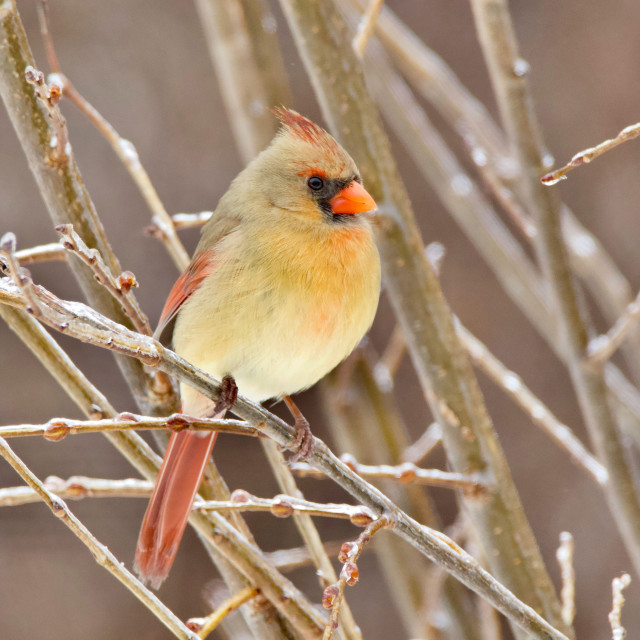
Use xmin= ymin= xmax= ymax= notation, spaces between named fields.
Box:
xmin=322 ymin=515 xmax=393 ymax=640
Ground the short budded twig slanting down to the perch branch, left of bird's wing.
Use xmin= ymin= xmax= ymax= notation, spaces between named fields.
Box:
xmin=56 ymin=224 xmax=152 ymax=336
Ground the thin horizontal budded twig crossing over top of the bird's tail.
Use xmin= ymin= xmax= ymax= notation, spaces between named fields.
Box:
xmin=0 ymin=413 xmax=258 ymax=442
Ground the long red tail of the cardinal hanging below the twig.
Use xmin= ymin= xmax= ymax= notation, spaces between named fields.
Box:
xmin=135 ymin=431 xmax=218 ymax=589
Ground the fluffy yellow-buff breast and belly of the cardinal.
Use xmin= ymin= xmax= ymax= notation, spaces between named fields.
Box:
xmin=174 ymin=220 xmax=380 ymax=400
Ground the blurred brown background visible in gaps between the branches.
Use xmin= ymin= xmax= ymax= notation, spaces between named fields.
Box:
xmin=0 ymin=0 xmax=640 ymax=640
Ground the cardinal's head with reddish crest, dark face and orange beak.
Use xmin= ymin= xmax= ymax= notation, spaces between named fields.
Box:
xmin=230 ymin=108 xmax=377 ymax=225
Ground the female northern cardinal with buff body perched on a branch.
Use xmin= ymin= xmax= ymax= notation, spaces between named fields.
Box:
xmin=135 ymin=109 xmax=380 ymax=588
